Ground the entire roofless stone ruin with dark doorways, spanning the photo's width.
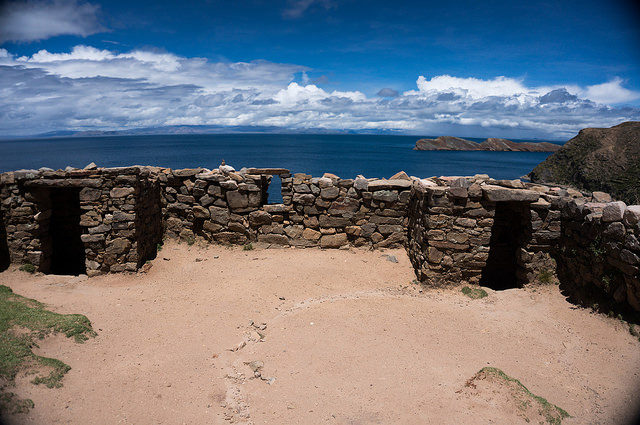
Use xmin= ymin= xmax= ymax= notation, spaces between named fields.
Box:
xmin=0 ymin=165 xmax=640 ymax=311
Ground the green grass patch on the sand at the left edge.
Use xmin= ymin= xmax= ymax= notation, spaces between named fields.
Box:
xmin=0 ymin=285 xmax=96 ymax=413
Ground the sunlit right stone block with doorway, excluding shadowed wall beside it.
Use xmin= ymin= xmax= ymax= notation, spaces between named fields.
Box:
xmin=407 ymin=175 xmax=578 ymax=287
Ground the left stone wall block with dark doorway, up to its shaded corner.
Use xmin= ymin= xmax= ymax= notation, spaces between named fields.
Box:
xmin=0 ymin=167 xmax=161 ymax=275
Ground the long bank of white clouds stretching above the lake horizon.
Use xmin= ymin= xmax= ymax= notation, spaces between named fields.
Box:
xmin=0 ymin=46 xmax=640 ymax=138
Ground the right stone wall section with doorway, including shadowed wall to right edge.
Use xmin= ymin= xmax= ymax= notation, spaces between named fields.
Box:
xmin=407 ymin=176 xmax=640 ymax=311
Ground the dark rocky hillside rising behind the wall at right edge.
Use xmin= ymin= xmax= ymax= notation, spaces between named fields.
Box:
xmin=529 ymin=121 xmax=640 ymax=204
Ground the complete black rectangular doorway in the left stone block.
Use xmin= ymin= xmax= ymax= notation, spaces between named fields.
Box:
xmin=49 ymin=188 xmax=86 ymax=275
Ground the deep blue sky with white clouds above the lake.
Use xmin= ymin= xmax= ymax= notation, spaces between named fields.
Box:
xmin=0 ymin=0 xmax=640 ymax=139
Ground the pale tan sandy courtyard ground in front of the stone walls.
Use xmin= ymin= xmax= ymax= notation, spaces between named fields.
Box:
xmin=0 ymin=243 xmax=640 ymax=424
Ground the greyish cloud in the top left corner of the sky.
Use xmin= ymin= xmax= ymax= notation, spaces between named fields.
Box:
xmin=0 ymin=0 xmax=104 ymax=44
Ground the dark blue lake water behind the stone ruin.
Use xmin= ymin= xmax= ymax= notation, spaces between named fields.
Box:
xmin=0 ymin=134 xmax=549 ymax=179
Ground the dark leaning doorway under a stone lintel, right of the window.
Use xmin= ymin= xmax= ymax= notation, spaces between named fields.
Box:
xmin=480 ymin=202 xmax=530 ymax=290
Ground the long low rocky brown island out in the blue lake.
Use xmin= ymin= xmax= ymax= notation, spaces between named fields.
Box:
xmin=414 ymin=136 xmax=561 ymax=152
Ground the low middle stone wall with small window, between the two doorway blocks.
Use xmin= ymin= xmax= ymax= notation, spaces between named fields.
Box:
xmin=158 ymin=166 xmax=411 ymax=248
